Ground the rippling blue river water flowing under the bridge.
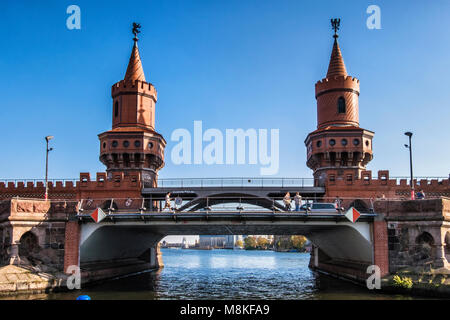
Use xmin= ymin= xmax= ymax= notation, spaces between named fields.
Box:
xmin=9 ymin=249 xmax=422 ymax=300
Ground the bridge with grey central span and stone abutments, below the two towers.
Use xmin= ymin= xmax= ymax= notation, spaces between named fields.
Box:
xmin=0 ymin=178 xmax=450 ymax=290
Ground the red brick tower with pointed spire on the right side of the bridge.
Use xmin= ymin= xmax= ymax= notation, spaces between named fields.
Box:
xmin=305 ymin=19 xmax=374 ymax=186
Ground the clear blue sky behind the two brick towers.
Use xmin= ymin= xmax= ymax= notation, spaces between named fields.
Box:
xmin=0 ymin=0 xmax=450 ymax=178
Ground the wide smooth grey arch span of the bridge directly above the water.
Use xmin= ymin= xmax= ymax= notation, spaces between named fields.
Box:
xmin=80 ymin=220 xmax=373 ymax=276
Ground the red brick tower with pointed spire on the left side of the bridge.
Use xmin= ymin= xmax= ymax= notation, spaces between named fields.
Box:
xmin=98 ymin=24 xmax=166 ymax=185
